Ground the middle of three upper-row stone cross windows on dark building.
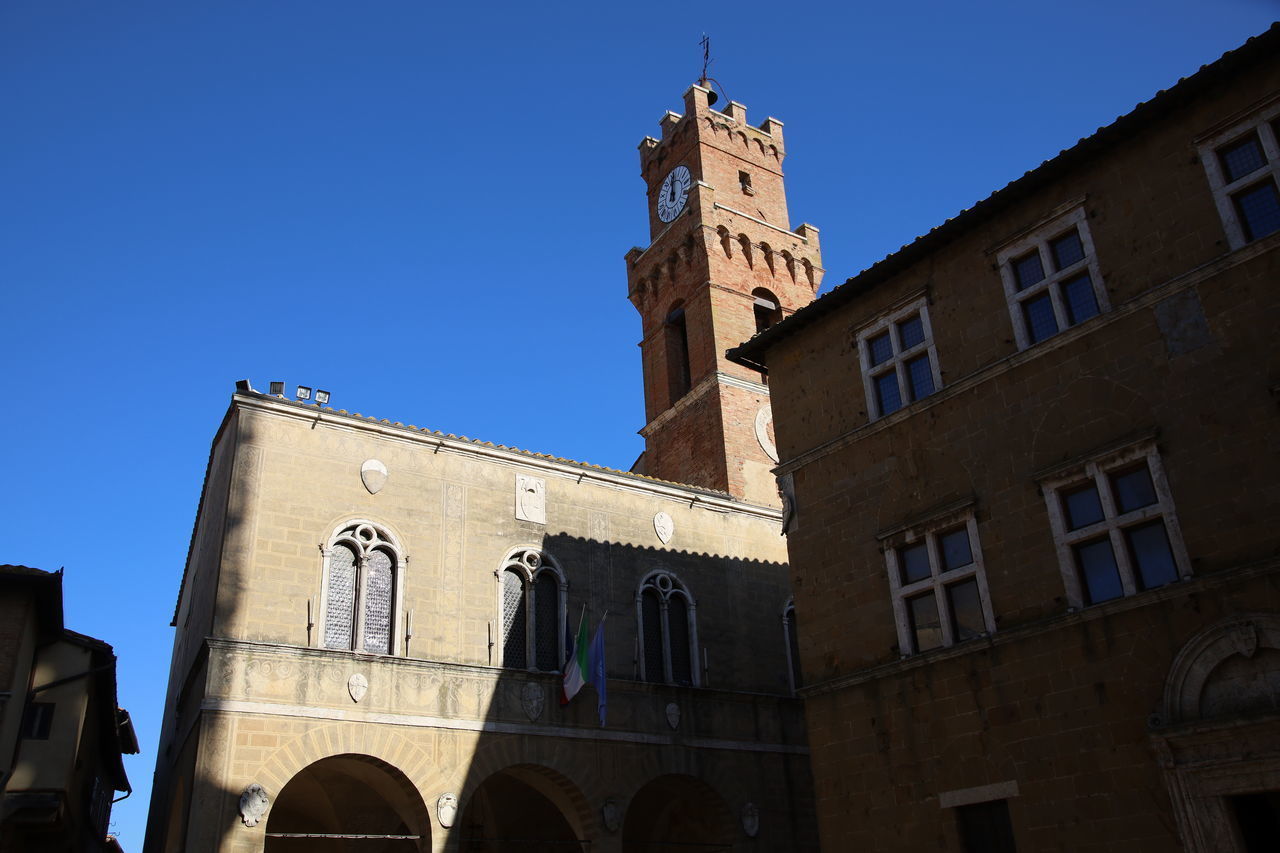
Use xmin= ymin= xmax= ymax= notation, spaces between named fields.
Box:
xmin=996 ymin=206 xmax=1111 ymax=350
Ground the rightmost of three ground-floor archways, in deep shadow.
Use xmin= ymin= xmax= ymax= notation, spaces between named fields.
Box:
xmin=622 ymin=775 xmax=733 ymax=853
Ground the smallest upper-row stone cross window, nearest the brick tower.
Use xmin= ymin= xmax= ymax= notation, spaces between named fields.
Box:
xmin=858 ymin=297 xmax=942 ymax=420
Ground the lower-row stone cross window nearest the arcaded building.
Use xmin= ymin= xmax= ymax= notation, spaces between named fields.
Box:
xmin=878 ymin=502 xmax=996 ymax=657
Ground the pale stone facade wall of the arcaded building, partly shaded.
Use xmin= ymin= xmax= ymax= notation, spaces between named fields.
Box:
xmin=147 ymin=394 xmax=813 ymax=850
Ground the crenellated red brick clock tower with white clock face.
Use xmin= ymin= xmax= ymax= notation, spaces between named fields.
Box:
xmin=626 ymin=86 xmax=823 ymax=506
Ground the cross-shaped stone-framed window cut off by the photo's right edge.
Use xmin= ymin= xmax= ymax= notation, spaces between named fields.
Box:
xmin=1197 ymin=101 xmax=1280 ymax=248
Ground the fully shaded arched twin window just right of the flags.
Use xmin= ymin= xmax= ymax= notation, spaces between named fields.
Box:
xmin=636 ymin=571 xmax=700 ymax=686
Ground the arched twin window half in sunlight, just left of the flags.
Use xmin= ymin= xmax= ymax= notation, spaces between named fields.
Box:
xmin=498 ymin=548 xmax=568 ymax=672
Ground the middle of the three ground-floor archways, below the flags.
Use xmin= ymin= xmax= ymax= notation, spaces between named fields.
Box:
xmin=454 ymin=766 xmax=589 ymax=853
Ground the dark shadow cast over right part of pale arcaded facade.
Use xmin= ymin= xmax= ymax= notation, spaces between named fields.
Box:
xmin=445 ymin=533 xmax=817 ymax=853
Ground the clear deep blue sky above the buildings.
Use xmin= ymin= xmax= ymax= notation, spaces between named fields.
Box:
xmin=0 ymin=0 xmax=1280 ymax=853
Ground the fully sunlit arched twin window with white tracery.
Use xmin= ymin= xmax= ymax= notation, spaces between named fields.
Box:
xmin=323 ymin=521 xmax=404 ymax=654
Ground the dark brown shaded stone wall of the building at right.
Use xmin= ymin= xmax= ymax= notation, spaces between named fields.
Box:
xmin=768 ymin=33 xmax=1280 ymax=852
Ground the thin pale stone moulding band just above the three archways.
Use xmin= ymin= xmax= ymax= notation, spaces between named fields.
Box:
xmin=200 ymin=699 xmax=809 ymax=756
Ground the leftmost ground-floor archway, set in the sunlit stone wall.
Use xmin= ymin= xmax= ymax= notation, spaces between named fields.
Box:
xmin=264 ymin=756 xmax=431 ymax=853
